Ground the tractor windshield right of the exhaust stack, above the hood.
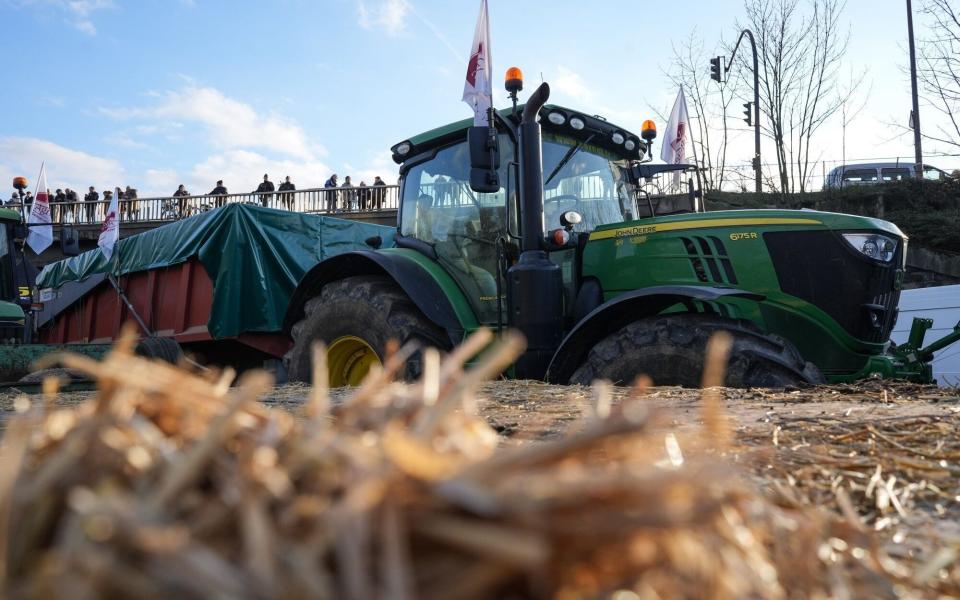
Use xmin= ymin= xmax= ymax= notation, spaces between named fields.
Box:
xmin=543 ymin=133 xmax=637 ymax=231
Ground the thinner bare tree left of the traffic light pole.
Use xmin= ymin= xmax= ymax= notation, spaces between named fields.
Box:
xmin=664 ymin=31 xmax=734 ymax=191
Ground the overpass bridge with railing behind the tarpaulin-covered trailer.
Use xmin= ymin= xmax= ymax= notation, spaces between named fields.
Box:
xmin=18 ymin=185 xmax=399 ymax=268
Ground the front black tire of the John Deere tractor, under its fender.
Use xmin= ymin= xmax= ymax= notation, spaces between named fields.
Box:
xmin=570 ymin=314 xmax=824 ymax=388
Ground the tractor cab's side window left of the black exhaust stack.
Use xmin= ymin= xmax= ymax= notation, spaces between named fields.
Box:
xmin=400 ymin=134 xmax=516 ymax=323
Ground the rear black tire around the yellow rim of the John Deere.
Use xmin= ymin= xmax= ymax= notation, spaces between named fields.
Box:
xmin=284 ymin=275 xmax=450 ymax=382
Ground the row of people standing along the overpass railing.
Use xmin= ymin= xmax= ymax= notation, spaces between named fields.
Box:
xmin=5 ymin=173 xmax=388 ymax=223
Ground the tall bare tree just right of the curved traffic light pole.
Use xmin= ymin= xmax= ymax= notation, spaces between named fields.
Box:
xmin=738 ymin=0 xmax=849 ymax=193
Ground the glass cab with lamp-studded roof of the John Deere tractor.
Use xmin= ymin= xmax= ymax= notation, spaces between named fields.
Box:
xmin=393 ymin=105 xmax=664 ymax=324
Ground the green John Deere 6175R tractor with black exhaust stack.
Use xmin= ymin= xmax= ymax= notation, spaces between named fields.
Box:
xmin=285 ymin=79 xmax=960 ymax=387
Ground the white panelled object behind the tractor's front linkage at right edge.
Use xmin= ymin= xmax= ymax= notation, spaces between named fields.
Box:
xmin=890 ymin=285 xmax=960 ymax=386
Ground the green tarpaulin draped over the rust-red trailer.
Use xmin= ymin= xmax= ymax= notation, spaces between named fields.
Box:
xmin=37 ymin=204 xmax=395 ymax=338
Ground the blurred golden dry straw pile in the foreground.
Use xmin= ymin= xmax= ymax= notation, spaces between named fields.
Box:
xmin=0 ymin=333 xmax=944 ymax=599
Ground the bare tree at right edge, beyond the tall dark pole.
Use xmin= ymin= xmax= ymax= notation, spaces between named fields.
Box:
xmin=917 ymin=0 xmax=960 ymax=147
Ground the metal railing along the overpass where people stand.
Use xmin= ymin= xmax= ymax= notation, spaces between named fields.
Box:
xmin=4 ymin=185 xmax=400 ymax=224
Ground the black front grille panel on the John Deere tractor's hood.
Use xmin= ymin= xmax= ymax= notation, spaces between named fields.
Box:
xmin=763 ymin=231 xmax=903 ymax=343
